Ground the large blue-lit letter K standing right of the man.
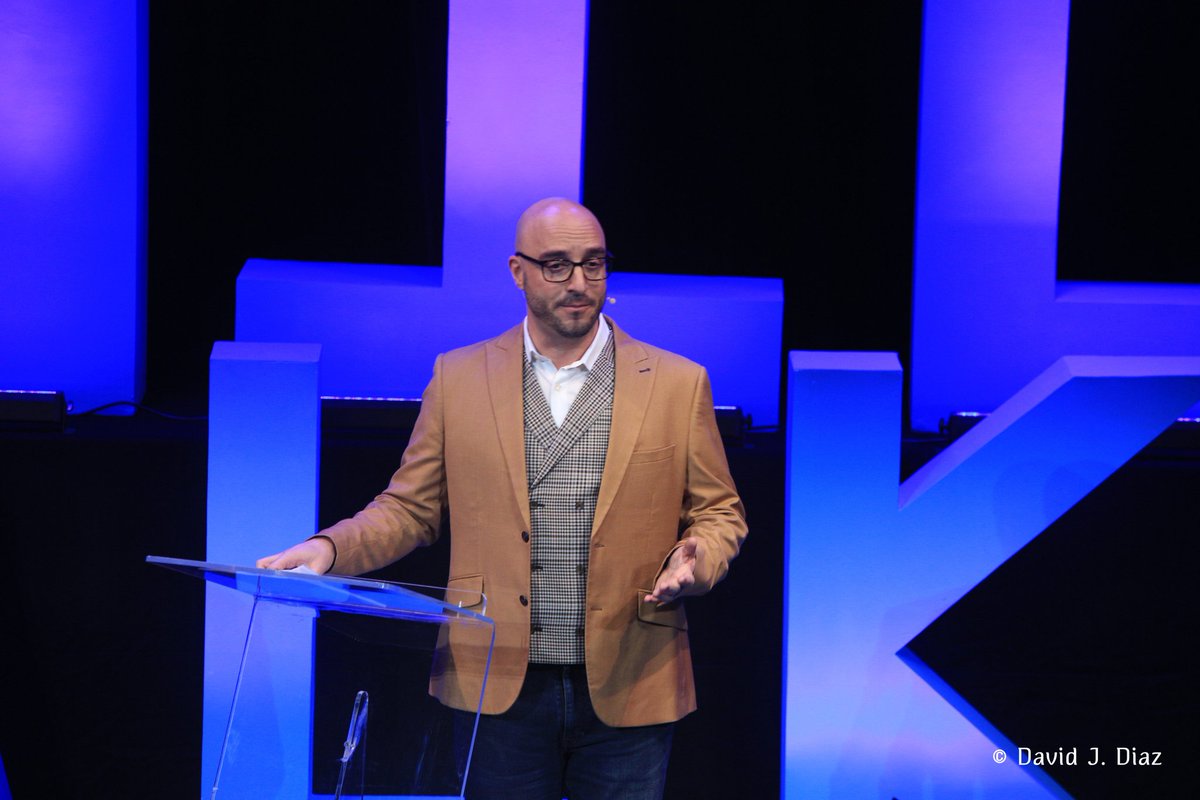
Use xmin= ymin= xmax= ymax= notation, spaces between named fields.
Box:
xmin=782 ymin=353 xmax=1200 ymax=800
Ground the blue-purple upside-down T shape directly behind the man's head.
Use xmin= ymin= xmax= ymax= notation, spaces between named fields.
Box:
xmin=236 ymin=0 xmax=784 ymax=425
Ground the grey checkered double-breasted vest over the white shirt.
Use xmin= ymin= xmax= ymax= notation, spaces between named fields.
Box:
xmin=524 ymin=337 xmax=616 ymax=663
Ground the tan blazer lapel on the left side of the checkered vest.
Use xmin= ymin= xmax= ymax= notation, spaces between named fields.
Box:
xmin=487 ymin=325 xmax=529 ymax=530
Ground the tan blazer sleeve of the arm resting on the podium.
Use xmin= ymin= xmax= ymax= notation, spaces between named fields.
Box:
xmin=318 ymin=355 xmax=446 ymax=575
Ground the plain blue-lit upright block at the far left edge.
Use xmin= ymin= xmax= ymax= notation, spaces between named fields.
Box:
xmin=0 ymin=0 xmax=146 ymax=410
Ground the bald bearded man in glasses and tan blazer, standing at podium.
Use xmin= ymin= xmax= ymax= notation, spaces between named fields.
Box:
xmin=258 ymin=198 xmax=746 ymax=800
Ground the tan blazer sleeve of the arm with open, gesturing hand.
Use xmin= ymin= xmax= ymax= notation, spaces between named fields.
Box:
xmin=662 ymin=368 xmax=748 ymax=596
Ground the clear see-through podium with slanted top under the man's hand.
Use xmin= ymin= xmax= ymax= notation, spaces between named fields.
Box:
xmin=146 ymin=555 xmax=496 ymax=800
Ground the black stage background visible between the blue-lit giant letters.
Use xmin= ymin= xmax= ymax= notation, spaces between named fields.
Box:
xmin=0 ymin=0 xmax=1200 ymax=798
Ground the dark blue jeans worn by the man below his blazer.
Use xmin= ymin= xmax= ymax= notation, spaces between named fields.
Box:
xmin=467 ymin=664 xmax=674 ymax=800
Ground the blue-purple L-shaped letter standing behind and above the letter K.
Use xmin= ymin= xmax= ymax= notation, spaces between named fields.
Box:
xmin=912 ymin=0 xmax=1200 ymax=431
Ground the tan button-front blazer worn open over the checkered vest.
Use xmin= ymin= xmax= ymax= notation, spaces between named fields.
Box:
xmin=322 ymin=316 xmax=746 ymax=726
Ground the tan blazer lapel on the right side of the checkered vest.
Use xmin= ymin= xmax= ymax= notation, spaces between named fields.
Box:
xmin=592 ymin=320 xmax=659 ymax=536
